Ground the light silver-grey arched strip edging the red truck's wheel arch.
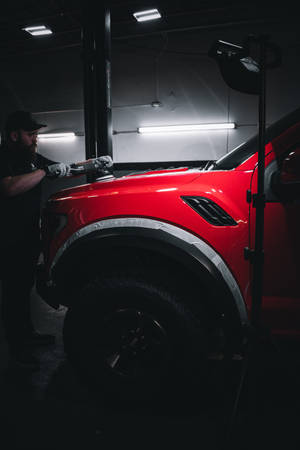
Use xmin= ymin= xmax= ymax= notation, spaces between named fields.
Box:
xmin=50 ymin=217 xmax=249 ymax=326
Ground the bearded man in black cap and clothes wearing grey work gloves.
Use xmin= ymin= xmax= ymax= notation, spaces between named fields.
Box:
xmin=0 ymin=111 xmax=112 ymax=367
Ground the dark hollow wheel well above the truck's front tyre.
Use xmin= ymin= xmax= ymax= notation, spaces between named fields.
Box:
xmin=53 ymin=232 xmax=246 ymax=328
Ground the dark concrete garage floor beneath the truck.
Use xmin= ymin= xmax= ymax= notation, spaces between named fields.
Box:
xmin=0 ymin=286 xmax=300 ymax=450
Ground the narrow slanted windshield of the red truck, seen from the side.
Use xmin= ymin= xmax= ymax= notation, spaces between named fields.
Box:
xmin=212 ymin=108 xmax=300 ymax=170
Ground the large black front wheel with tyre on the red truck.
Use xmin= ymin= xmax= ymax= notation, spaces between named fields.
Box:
xmin=63 ymin=274 xmax=207 ymax=393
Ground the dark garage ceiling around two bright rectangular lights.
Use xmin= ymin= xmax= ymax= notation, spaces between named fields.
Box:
xmin=0 ymin=0 xmax=298 ymax=59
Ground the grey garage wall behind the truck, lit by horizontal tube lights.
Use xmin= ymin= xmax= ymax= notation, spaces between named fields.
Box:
xmin=0 ymin=24 xmax=300 ymax=174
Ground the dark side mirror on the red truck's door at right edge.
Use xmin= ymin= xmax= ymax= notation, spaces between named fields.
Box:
xmin=272 ymin=147 xmax=300 ymax=201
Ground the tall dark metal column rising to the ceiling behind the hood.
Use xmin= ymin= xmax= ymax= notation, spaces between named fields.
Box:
xmin=82 ymin=1 xmax=112 ymax=172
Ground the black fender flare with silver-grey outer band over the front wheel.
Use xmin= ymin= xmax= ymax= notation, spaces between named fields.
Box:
xmin=50 ymin=217 xmax=249 ymax=326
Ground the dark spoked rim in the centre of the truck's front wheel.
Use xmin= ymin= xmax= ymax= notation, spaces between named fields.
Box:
xmin=104 ymin=308 xmax=170 ymax=380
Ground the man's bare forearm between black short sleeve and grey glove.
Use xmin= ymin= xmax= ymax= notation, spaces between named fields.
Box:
xmin=0 ymin=169 xmax=46 ymax=197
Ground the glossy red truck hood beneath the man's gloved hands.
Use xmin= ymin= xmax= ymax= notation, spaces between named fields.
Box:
xmin=50 ymin=167 xmax=203 ymax=200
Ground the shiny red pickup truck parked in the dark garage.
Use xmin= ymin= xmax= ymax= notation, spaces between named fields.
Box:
xmin=37 ymin=109 xmax=300 ymax=391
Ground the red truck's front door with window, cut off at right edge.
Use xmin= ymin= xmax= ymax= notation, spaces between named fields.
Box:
xmin=250 ymin=125 xmax=300 ymax=337
